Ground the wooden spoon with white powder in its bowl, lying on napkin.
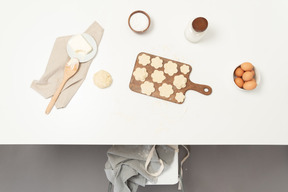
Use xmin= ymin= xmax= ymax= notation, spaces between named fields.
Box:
xmin=45 ymin=58 xmax=79 ymax=115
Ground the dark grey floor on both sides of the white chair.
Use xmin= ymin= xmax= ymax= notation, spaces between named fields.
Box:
xmin=0 ymin=146 xmax=288 ymax=192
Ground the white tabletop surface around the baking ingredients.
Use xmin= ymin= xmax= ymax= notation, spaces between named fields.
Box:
xmin=0 ymin=0 xmax=288 ymax=144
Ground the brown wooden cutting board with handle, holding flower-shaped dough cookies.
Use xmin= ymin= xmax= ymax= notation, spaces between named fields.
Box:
xmin=129 ymin=52 xmax=212 ymax=104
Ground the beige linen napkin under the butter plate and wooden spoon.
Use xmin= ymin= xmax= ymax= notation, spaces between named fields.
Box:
xmin=31 ymin=22 xmax=104 ymax=108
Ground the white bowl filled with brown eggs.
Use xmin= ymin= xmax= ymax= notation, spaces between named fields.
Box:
xmin=233 ymin=62 xmax=260 ymax=91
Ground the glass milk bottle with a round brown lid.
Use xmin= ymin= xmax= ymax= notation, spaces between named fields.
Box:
xmin=185 ymin=17 xmax=208 ymax=43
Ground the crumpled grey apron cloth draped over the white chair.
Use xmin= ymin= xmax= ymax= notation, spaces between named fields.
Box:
xmin=105 ymin=145 xmax=175 ymax=192
